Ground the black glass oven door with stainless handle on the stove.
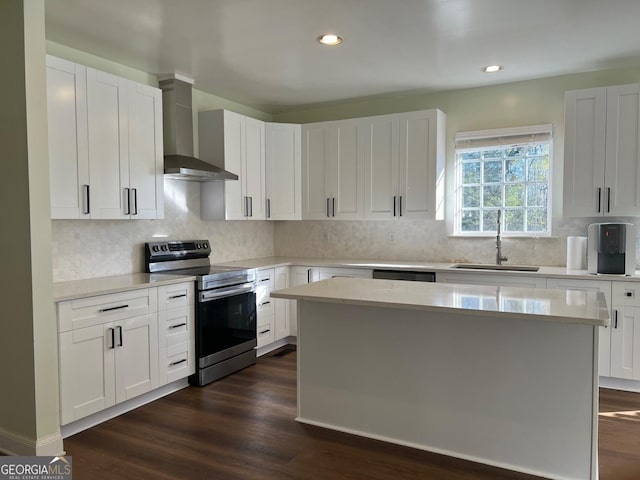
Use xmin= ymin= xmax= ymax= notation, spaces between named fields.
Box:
xmin=196 ymin=283 xmax=257 ymax=368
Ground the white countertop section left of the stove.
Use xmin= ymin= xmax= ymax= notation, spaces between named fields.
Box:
xmin=53 ymin=273 xmax=196 ymax=302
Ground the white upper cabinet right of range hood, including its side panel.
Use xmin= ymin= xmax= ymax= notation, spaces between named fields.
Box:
xmin=198 ymin=110 xmax=266 ymax=220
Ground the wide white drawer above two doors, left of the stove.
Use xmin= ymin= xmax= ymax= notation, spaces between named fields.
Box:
xmin=58 ymin=288 xmax=158 ymax=332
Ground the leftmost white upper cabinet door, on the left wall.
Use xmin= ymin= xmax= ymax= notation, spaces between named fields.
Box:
xmin=47 ymin=56 xmax=91 ymax=218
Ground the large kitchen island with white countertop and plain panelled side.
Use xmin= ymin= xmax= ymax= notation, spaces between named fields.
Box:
xmin=272 ymin=278 xmax=609 ymax=479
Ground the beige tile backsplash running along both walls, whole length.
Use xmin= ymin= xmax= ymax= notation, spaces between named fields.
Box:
xmin=52 ymin=180 xmax=640 ymax=282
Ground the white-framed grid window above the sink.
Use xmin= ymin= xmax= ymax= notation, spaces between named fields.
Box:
xmin=455 ymin=125 xmax=551 ymax=236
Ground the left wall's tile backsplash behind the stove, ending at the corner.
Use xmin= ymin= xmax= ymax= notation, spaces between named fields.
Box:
xmin=52 ymin=179 xmax=274 ymax=282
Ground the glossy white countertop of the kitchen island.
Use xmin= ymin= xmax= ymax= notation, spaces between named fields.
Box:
xmin=271 ymin=277 xmax=610 ymax=326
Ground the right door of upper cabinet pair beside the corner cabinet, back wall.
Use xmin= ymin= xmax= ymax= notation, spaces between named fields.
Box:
xmin=328 ymin=119 xmax=364 ymax=220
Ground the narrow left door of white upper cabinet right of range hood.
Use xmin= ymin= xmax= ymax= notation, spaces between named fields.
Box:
xmin=223 ymin=110 xmax=246 ymax=220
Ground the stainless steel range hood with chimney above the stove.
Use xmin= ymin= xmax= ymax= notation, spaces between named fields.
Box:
xmin=160 ymin=78 xmax=238 ymax=182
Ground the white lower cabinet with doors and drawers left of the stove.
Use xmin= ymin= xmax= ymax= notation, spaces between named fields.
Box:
xmin=57 ymin=282 xmax=195 ymax=425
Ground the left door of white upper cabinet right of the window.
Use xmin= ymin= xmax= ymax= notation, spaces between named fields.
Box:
xmin=563 ymin=88 xmax=607 ymax=217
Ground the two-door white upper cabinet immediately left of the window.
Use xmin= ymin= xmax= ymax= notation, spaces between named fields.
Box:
xmin=363 ymin=110 xmax=446 ymax=220
